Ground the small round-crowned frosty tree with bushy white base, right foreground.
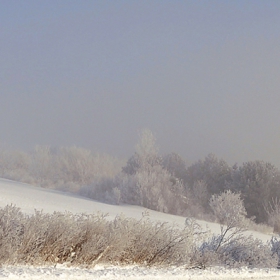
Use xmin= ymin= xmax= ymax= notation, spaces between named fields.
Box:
xmin=189 ymin=191 xmax=278 ymax=267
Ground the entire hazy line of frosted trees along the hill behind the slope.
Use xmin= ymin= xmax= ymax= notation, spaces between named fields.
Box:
xmin=0 ymin=129 xmax=280 ymax=232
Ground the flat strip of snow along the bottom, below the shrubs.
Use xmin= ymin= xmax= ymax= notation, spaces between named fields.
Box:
xmin=0 ymin=265 xmax=280 ymax=280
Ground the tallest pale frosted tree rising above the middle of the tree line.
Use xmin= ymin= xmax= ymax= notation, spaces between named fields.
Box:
xmin=122 ymin=129 xmax=186 ymax=213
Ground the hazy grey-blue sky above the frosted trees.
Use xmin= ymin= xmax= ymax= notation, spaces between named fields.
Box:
xmin=0 ymin=0 xmax=280 ymax=167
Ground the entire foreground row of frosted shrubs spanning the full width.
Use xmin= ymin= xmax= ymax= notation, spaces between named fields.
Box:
xmin=0 ymin=205 xmax=280 ymax=268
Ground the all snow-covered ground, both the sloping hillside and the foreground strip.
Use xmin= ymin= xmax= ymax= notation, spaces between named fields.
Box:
xmin=0 ymin=179 xmax=280 ymax=280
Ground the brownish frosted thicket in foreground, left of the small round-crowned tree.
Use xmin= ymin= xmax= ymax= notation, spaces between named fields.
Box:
xmin=0 ymin=206 xmax=197 ymax=266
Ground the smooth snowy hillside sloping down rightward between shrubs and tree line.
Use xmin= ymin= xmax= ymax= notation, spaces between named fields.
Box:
xmin=0 ymin=179 xmax=271 ymax=241
